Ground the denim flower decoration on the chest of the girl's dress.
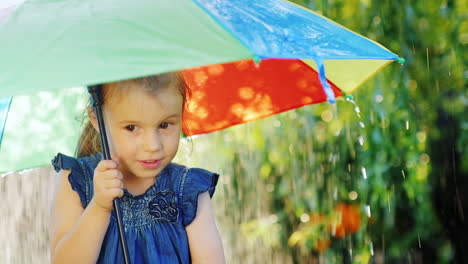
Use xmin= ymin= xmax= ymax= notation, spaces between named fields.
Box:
xmin=148 ymin=190 xmax=179 ymax=222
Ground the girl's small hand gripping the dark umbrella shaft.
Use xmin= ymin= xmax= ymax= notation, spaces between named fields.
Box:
xmin=93 ymin=160 xmax=124 ymax=212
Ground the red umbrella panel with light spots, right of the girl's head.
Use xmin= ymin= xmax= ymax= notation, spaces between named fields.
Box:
xmin=183 ymin=59 xmax=343 ymax=136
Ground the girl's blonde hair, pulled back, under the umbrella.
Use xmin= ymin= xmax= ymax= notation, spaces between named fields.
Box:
xmin=75 ymin=72 xmax=191 ymax=158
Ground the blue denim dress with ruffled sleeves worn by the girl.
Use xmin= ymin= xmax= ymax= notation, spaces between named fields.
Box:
xmin=52 ymin=153 xmax=219 ymax=264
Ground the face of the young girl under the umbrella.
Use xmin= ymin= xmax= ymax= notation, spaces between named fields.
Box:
xmin=92 ymin=83 xmax=183 ymax=180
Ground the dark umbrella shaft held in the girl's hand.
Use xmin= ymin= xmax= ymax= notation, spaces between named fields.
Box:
xmin=88 ymin=85 xmax=130 ymax=264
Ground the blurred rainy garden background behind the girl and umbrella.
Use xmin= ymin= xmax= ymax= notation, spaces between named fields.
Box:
xmin=0 ymin=0 xmax=468 ymax=263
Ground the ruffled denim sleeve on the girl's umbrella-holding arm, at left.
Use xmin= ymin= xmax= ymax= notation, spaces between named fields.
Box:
xmin=52 ymin=153 xmax=88 ymax=207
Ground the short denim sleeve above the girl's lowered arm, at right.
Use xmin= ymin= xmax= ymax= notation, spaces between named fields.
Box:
xmin=180 ymin=168 xmax=219 ymax=226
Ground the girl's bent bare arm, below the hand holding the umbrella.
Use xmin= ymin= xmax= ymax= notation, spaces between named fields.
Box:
xmin=50 ymin=170 xmax=110 ymax=263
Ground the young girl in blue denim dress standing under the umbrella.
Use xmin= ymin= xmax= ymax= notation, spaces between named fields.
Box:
xmin=51 ymin=73 xmax=224 ymax=264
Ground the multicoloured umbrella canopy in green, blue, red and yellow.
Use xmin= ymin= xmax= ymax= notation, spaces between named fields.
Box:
xmin=0 ymin=0 xmax=398 ymax=171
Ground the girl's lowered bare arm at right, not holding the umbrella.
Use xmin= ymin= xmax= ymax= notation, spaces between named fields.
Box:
xmin=185 ymin=192 xmax=225 ymax=264
